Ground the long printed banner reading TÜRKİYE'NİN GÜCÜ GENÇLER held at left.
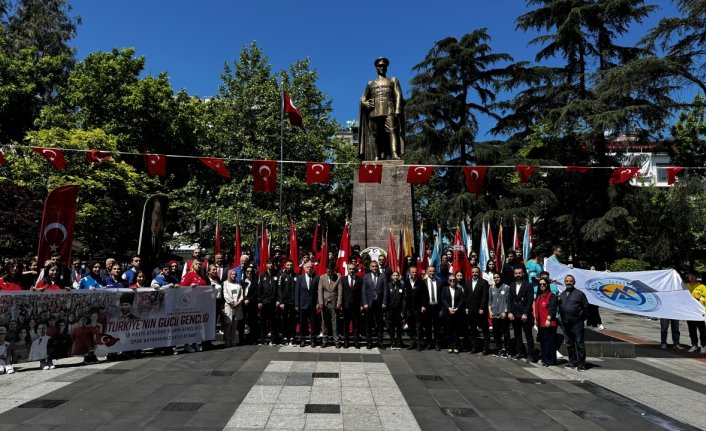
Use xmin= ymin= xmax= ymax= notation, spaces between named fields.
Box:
xmin=0 ymin=286 xmax=216 ymax=359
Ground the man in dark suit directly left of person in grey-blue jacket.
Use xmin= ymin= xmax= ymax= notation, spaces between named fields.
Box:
xmin=466 ymin=266 xmax=490 ymax=356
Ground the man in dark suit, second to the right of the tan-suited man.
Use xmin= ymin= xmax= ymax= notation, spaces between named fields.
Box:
xmin=361 ymin=261 xmax=388 ymax=350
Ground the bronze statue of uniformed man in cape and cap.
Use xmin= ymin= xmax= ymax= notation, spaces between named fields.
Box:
xmin=358 ymin=57 xmax=405 ymax=160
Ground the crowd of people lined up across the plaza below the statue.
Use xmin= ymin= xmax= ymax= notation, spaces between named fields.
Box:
xmin=0 ymin=243 xmax=706 ymax=373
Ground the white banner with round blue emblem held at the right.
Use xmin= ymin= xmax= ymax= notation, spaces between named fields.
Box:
xmin=545 ymin=260 xmax=706 ymax=320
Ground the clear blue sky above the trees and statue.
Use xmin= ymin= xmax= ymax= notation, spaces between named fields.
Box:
xmin=71 ymin=0 xmax=676 ymax=135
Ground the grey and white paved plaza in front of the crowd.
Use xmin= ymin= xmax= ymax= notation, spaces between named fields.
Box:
xmin=0 ymin=312 xmax=706 ymax=431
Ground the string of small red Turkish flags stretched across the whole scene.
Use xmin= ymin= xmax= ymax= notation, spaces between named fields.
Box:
xmin=0 ymin=145 xmax=692 ymax=194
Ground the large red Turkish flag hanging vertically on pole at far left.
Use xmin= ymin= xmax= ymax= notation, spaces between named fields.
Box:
xmin=37 ymin=185 xmax=78 ymax=263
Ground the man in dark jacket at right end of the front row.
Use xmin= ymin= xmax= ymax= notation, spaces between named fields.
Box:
xmin=557 ymin=274 xmax=588 ymax=371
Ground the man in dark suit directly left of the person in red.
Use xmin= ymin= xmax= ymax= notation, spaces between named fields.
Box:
xmin=508 ymin=268 xmax=534 ymax=363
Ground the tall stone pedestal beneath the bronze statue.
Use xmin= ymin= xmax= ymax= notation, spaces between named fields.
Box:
xmin=351 ymin=160 xmax=415 ymax=254
